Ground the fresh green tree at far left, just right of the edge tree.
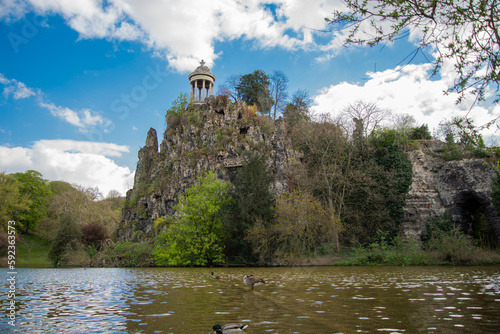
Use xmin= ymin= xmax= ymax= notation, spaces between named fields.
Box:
xmin=14 ymin=170 xmax=52 ymax=232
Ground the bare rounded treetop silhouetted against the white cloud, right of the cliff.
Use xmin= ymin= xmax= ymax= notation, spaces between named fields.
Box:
xmin=339 ymin=100 xmax=392 ymax=138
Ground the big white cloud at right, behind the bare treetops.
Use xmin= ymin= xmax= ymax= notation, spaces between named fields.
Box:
xmin=313 ymin=64 xmax=500 ymax=140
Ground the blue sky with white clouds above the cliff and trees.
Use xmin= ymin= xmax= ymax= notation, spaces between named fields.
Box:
xmin=0 ymin=0 xmax=500 ymax=196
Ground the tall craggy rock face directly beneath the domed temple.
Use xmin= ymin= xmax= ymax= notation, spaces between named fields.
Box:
xmin=117 ymin=96 xmax=299 ymax=240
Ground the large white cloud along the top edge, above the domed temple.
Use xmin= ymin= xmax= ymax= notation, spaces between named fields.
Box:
xmin=0 ymin=0 xmax=344 ymax=71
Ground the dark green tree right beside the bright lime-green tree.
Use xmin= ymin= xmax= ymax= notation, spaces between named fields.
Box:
xmin=226 ymin=155 xmax=275 ymax=259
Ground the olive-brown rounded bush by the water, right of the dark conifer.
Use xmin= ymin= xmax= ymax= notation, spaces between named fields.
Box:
xmin=247 ymin=191 xmax=339 ymax=263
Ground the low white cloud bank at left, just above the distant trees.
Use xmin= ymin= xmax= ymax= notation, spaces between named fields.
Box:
xmin=0 ymin=140 xmax=134 ymax=195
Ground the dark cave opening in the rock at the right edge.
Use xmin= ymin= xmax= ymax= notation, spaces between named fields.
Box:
xmin=454 ymin=191 xmax=497 ymax=248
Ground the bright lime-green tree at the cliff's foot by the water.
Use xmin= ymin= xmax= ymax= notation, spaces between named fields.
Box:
xmin=155 ymin=171 xmax=230 ymax=266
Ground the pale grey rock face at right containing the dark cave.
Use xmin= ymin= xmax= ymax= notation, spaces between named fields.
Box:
xmin=401 ymin=141 xmax=500 ymax=242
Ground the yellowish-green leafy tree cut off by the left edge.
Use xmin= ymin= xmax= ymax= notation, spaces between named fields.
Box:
xmin=0 ymin=172 xmax=31 ymax=231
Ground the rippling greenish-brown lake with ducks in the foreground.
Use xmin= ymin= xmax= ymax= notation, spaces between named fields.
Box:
xmin=0 ymin=266 xmax=500 ymax=333
